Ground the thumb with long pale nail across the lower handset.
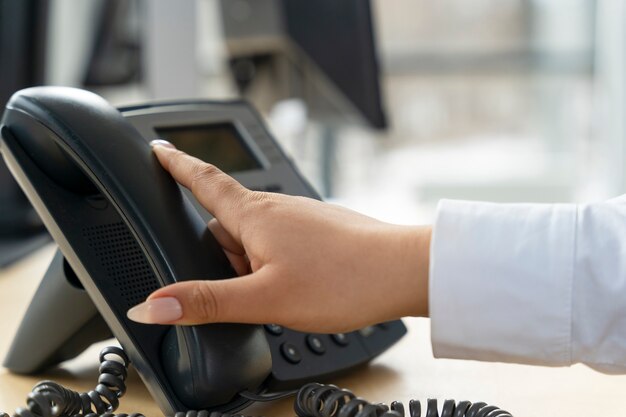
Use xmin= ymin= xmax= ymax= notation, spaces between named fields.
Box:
xmin=127 ymin=268 xmax=280 ymax=325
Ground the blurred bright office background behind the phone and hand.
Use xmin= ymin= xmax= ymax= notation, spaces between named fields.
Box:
xmin=0 ymin=0 xmax=626 ymax=260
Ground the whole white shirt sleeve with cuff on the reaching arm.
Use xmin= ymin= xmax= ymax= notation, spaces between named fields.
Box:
xmin=429 ymin=197 xmax=626 ymax=372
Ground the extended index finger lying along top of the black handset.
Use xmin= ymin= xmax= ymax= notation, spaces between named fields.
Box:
xmin=152 ymin=141 xmax=248 ymax=230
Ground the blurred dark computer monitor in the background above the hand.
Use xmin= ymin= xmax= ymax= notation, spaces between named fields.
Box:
xmin=221 ymin=0 xmax=387 ymax=129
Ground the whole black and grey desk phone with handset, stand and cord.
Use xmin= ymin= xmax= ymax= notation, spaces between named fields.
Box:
xmin=0 ymin=87 xmax=509 ymax=417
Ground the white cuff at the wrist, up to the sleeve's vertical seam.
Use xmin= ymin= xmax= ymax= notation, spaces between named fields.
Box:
xmin=429 ymin=200 xmax=576 ymax=365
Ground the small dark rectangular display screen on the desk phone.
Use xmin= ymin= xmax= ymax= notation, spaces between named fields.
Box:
xmin=155 ymin=123 xmax=262 ymax=173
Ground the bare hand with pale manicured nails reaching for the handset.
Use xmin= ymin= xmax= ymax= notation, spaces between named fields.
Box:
xmin=128 ymin=141 xmax=431 ymax=333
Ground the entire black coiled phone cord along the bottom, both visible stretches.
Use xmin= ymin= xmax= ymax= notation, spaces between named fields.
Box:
xmin=0 ymin=347 xmax=512 ymax=417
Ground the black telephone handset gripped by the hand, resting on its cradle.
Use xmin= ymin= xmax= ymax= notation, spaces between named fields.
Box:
xmin=2 ymin=87 xmax=271 ymax=413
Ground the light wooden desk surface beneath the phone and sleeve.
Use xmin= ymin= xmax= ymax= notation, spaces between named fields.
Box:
xmin=0 ymin=246 xmax=626 ymax=417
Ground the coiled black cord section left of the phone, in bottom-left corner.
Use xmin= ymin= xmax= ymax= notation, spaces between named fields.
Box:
xmin=5 ymin=346 xmax=143 ymax=417
